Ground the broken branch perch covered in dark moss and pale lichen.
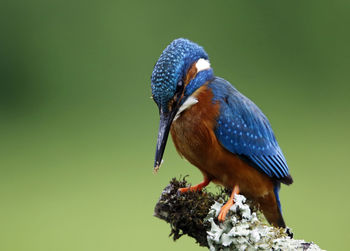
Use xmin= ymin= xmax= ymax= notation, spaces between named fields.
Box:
xmin=154 ymin=178 xmax=321 ymax=251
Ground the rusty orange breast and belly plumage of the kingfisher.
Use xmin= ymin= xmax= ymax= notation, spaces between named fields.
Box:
xmin=171 ymin=85 xmax=273 ymax=198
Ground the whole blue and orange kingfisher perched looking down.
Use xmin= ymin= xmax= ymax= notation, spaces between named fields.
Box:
xmin=151 ymin=38 xmax=293 ymax=228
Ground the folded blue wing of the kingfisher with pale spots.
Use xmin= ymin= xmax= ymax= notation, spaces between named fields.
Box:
xmin=209 ymin=78 xmax=292 ymax=184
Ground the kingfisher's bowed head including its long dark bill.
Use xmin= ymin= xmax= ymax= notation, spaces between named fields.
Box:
xmin=151 ymin=38 xmax=213 ymax=171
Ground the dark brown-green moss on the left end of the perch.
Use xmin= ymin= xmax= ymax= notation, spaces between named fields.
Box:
xmin=154 ymin=177 xmax=256 ymax=247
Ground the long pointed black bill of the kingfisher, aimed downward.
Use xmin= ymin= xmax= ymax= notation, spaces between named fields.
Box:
xmin=154 ymin=111 xmax=176 ymax=172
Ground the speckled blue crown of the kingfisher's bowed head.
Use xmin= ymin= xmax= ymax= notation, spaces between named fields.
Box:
xmin=151 ymin=38 xmax=208 ymax=110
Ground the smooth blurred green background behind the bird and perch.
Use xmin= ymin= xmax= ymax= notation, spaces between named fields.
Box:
xmin=0 ymin=0 xmax=350 ymax=251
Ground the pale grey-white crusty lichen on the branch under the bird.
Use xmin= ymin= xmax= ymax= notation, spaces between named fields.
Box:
xmin=204 ymin=195 xmax=321 ymax=251
